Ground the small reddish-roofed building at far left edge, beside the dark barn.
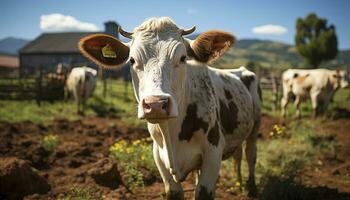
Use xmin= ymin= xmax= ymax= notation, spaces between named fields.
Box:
xmin=0 ymin=54 xmax=19 ymax=77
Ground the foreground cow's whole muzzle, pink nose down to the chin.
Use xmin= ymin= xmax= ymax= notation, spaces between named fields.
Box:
xmin=141 ymin=96 xmax=172 ymax=123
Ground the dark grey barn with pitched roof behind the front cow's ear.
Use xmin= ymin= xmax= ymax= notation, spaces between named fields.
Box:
xmin=19 ymin=21 xmax=128 ymax=76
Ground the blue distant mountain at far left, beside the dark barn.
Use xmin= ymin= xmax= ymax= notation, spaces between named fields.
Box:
xmin=0 ymin=37 xmax=30 ymax=54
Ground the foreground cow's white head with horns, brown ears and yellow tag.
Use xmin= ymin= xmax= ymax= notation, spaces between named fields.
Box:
xmin=79 ymin=17 xmax=235 ymax=123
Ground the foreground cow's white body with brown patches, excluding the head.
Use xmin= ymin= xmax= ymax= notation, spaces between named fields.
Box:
xmin=148 ymin=62 xmax=260 ymax=197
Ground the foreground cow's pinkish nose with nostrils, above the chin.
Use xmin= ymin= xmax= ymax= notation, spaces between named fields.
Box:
xmin=142 ymin=96 xmax=169 ymax=117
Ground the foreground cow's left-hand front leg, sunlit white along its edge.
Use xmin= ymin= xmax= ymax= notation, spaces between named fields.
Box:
xmin=153 ymin=143 xmax=184 ymax=200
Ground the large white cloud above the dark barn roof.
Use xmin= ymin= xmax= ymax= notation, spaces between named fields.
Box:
xmin=40 ymin=13 xmax=99 ymax=32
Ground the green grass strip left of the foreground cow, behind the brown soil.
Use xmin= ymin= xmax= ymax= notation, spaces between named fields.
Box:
xmin=0 ymin=80 xmax=144 ymax=126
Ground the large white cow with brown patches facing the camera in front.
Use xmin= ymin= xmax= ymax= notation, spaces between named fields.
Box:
xmin=79 ymin=17 xmax=260 ymax=199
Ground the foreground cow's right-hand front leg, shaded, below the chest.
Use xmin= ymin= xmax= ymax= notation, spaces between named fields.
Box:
xmin=195 ymin=150 xmax=222 ymax=200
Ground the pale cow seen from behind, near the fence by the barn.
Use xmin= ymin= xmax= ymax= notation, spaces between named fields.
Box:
xmin=66 ymin=66 xmax=97 ymax=114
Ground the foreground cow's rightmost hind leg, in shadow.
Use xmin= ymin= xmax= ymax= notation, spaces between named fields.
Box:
xmin=245 ymin=119 xmax=260 ymax=197
